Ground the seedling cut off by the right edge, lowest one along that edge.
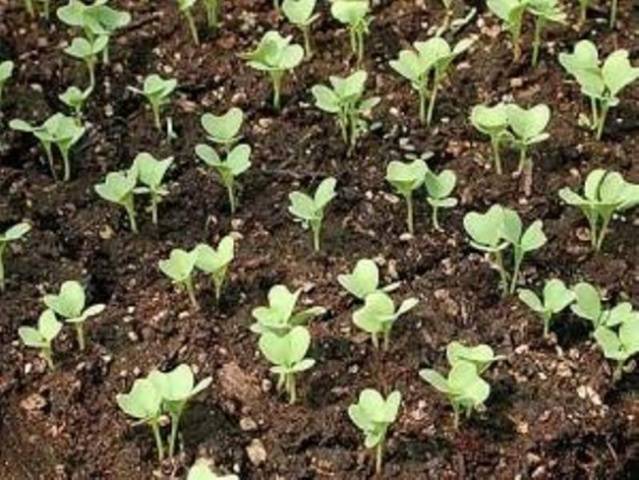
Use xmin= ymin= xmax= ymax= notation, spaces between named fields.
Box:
xmin=594 ymin=316 xmax=639 ymax=381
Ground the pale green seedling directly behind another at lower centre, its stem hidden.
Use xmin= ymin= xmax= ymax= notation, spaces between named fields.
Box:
xmin=251 ymin=285 xmax=326 ymax=336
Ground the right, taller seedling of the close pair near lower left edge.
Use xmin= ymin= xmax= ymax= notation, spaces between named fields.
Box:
xmin=44 ymin=281 xmax=105 ymax=350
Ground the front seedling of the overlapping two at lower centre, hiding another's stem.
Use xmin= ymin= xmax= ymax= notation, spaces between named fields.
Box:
xmin=259 ymin=326 xmax=315 ymax=405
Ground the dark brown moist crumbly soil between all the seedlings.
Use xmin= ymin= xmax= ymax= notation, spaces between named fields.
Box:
xmin=0 ymin=0 xmax=639 ymax=480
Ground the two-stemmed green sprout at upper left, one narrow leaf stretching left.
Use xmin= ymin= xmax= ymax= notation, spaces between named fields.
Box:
xmin=9 ymin=113 xmax=86 ymax=182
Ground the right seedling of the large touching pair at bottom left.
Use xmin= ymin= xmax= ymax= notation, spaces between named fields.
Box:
xmin=148 ymin=364 xmax=213 ymax=457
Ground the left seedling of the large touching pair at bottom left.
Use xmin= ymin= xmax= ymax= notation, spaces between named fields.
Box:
xmin=116 ymin=378 xmax=164 ymax=462
